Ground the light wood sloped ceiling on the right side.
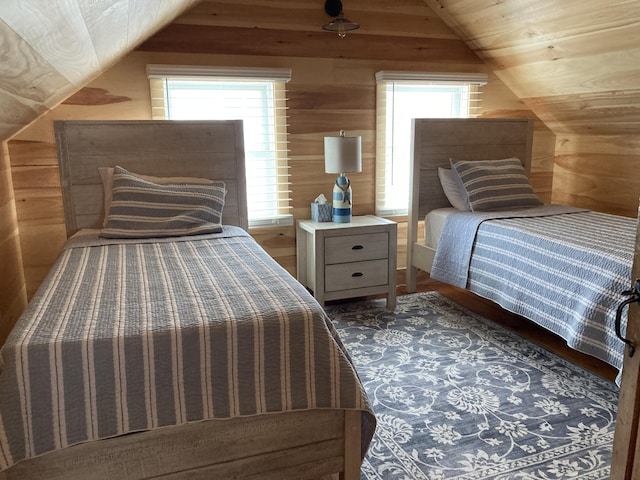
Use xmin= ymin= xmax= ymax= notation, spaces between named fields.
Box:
xmin=424 ymin=0 xmax=640 ymax=135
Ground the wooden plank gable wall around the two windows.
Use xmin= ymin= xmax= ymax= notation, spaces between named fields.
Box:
xmin=1 ymin=0 xmax=555 ymax=330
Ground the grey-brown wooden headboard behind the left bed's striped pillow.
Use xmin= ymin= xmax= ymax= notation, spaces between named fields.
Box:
xmin=54 ymin=120 xmax=248 ymax=236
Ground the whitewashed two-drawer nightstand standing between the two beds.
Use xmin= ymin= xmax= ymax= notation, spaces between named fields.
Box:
xmin=296 ymin=215 xmax=397 ymax=308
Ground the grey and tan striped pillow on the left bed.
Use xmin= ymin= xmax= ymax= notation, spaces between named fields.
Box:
xmin=99 ymin=167 xmax=226 ymax=238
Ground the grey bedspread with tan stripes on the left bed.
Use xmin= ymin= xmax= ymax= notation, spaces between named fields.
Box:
xmin=0 ymin=227 xmax=375 ymax=469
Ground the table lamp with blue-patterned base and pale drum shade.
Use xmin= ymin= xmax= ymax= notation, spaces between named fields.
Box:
xmin=324 ymin=130 xmax=362 ymax=223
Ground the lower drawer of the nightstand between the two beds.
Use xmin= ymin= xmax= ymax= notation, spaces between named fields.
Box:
xmin=324 ymin=259 xmax=389 ymax=292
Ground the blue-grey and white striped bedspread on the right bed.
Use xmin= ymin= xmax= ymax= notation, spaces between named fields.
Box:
xmin=431 ymin=206 xmax=637 ymax=381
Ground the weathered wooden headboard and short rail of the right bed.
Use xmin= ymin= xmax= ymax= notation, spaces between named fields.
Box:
xmin=407 ymin=118 xmax=533 ymax=292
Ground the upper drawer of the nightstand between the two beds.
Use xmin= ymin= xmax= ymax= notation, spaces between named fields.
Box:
xmin=324 ymin=232 xmax=389 ymax=265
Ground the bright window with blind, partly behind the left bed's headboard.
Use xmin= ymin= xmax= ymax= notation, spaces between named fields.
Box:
xmin=147 ymin=65 xmax=293 ymax=227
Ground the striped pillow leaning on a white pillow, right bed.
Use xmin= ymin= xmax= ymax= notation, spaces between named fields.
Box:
xmin=450 ymin=157 xmax=543 ymax=212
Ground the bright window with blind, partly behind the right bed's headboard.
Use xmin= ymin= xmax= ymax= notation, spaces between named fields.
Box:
xmin=376 ymin=72 xmax=487 ymax=216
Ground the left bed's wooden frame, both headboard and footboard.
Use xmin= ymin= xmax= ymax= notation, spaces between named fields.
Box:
xmin=0 ymin=121 xmax=362 ymax=480
